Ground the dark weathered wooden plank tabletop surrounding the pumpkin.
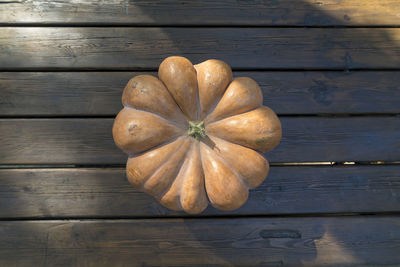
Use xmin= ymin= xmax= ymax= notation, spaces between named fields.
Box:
xmin=0 ymin=0 xmax=400 ymax=266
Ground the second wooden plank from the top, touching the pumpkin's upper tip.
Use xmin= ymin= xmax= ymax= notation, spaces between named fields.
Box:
xmin=0 ymin=27 xmax=400 ymax=70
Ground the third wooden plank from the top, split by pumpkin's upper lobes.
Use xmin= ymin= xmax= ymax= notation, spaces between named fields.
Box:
xmin=0 ymin=71 xmax=400 ymax=116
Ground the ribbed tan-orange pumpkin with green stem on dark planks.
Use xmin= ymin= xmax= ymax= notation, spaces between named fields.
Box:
xmin=113 ymin=56 xmax=282 ymax=214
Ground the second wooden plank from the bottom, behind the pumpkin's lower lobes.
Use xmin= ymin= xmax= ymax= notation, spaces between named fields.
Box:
xmin=0 ymin=165 xmax=400 ymax=219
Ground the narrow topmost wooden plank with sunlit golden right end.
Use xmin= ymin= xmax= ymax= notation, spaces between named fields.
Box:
xmin=0 ymin=0 xmax=400 ymax=26
